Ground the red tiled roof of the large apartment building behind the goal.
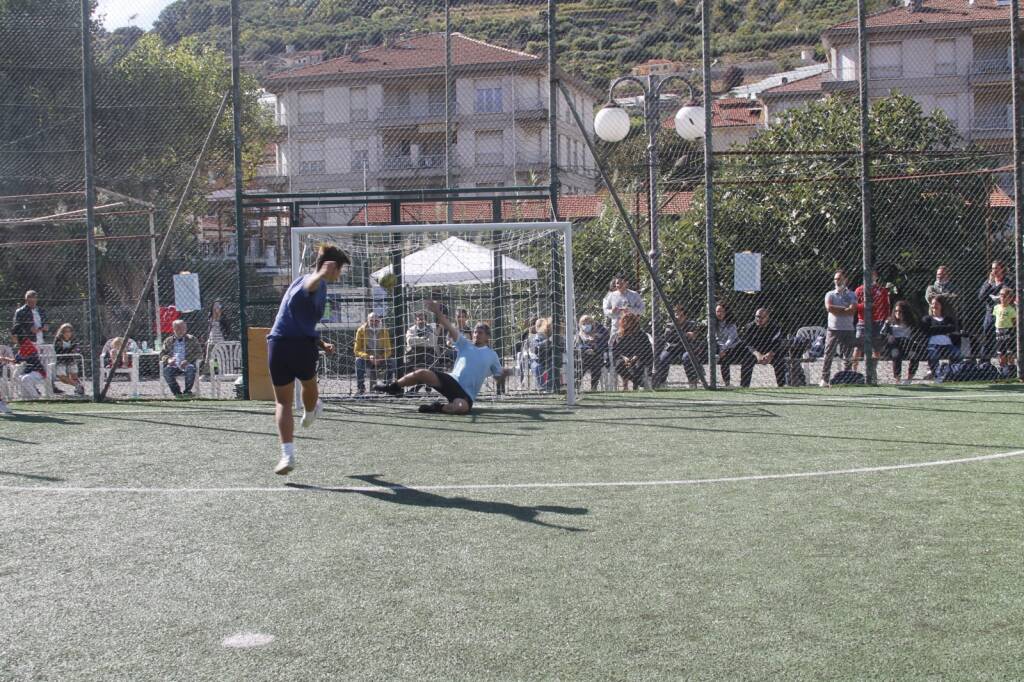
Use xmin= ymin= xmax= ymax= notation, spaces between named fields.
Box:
xmin=266 ymin=33 xmax=543 ymax=82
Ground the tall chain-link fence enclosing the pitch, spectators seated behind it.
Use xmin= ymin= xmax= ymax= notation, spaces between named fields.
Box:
xmin=0 ymin=0 xmax=1019 ymax=397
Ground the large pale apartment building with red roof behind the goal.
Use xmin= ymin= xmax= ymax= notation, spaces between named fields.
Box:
xmin=264 ymin=33 xmax=600 ymax=204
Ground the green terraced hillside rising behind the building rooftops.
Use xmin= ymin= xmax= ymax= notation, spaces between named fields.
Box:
xmin=140 ymin=0 xmax=897 ymax=84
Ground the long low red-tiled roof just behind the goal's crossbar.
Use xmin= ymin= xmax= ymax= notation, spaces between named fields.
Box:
xmin=349 ymin=191 xmax=693 ymax=225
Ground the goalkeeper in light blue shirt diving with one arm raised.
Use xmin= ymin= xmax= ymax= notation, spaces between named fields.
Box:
xmin=374 ymin=301 xmax=512 ymax=415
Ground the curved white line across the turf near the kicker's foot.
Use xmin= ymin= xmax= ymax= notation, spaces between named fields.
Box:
xmin=0 ymin=450 xmax=1024 ymax=495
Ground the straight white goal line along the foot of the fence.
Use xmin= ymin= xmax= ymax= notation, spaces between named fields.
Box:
xmin=9 ymin=389 xmax=1024 ymax=423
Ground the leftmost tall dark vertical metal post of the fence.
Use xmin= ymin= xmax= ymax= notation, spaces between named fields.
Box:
xmin=82 ymin=0 xmax=100 ymax=402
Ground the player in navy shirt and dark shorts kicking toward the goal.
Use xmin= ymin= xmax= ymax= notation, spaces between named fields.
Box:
xmin=266 ymin=245 xmax=350 ymax=475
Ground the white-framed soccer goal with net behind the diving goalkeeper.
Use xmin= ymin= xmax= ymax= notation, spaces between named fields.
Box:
xmin=292 ymin=222 xmax=577 ymax=404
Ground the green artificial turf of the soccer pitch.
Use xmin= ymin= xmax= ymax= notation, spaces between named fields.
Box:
xmin=0 ymin=386 xmax=1024 ymax=681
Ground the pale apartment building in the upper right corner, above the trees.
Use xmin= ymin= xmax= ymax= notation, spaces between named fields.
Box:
xmin=821 ymin=0 xmax=1013 ymax=148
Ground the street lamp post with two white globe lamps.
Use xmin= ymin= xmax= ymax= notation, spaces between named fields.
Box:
xmin=594 ymin=75 xmax=710 ymax=366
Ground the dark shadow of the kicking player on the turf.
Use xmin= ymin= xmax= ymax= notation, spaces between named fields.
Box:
xmin=286 ymin=474 xmax=587 ymax=532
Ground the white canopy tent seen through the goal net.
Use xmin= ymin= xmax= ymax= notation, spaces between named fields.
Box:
xmin=370 ymin=237 xmax=537 ymax=287
